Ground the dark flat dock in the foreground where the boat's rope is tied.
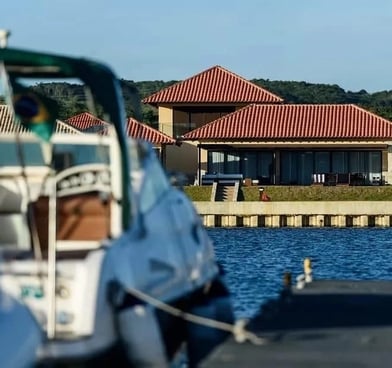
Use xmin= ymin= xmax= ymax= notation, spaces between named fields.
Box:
xmin=201 ymin=280 xmax=392 ymax=368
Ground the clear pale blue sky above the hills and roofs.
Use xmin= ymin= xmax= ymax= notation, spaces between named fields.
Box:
xmin=0 ymin=0 xmax=392 ymax=93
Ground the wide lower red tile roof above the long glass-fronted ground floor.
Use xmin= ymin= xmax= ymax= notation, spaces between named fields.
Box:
xmin=183 ymin=104 xmax=392 ymax=141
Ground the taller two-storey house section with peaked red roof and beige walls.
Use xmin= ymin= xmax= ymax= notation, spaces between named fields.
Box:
xmin=142 ymin=66 xmax=283 ymax=183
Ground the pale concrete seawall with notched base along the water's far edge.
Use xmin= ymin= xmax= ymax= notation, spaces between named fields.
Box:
xmin=193 ymin=201 xmax=392 ymax=227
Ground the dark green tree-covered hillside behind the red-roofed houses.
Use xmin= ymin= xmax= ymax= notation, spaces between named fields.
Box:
xmin=26 ymin=79 xmax=392 ymax=126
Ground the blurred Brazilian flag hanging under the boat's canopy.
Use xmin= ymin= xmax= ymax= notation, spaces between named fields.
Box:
xmin=12 ymin=83 xmax=58 ymax=141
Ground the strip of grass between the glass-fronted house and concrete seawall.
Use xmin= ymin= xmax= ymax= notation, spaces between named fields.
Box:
xmin=184 ymin=186 xmax=392 ymax=201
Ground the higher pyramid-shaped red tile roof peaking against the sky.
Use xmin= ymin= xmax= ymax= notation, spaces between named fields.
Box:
xmin=142 ymin=65 xmax=283 ymax=105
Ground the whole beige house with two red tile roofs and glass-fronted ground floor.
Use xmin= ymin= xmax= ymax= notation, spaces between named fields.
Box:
xmin=143 ymin=66 xmax=392 ymax=185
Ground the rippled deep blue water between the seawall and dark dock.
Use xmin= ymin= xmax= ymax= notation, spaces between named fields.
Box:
xmin=208 ymin=228 xmax=392 ymax=318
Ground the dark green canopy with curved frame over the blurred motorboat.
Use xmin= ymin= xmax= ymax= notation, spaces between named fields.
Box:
xmin=0 ymin=48 xmax=131 ymax=229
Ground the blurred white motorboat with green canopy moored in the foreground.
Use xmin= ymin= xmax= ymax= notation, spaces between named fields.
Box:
xmin=0 ymin=33 xmax=233 ymax=367
